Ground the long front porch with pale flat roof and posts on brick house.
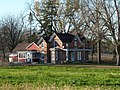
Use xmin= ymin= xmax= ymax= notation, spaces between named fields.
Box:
xmin=50 ymin=48 xmax=92 ymax=64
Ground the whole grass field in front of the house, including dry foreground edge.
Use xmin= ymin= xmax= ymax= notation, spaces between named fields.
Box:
xmin=0 ymin=65 xmax=120 ymax=90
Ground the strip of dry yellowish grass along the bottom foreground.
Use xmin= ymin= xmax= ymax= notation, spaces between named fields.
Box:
xmin=0 ymin=84 xmax=120 ymax=90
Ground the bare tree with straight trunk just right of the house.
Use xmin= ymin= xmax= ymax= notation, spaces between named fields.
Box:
xmin=77 ymin=0 xmax=105 ymax=64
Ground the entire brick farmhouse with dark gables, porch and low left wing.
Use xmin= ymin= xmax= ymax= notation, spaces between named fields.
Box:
xmin=9 ymin=33 xmax=92 ymax=64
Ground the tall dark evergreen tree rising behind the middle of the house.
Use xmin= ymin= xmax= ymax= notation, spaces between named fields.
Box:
xmin=35 ymin=0 xmax=59 ymax=36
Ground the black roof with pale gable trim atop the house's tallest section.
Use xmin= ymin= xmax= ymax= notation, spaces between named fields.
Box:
xmin=49 ymin=33 xmax=75 ymax=43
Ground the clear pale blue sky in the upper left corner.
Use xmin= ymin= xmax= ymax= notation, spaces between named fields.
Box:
xmin=0 ymin=0 xmax=32 ymax=17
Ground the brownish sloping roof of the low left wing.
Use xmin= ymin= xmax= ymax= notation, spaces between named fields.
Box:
xmin=12 ymin=42 xmax=30 ymax=53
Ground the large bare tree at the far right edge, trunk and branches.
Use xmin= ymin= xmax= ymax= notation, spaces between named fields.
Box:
xmin=100 ymin=0 xmax=120 ymax=66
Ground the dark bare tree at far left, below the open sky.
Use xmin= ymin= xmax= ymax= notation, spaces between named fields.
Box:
xmin=0 ymin=16 xmax=24 ymax=52
